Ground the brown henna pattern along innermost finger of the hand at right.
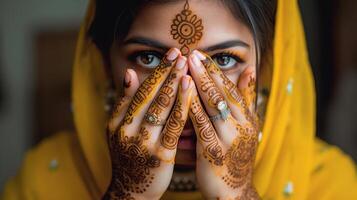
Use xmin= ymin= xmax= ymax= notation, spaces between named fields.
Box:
xmin=190 ymin=97 xmax=224 ymax=166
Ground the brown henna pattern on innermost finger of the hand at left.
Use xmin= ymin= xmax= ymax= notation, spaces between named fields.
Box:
xmin=161 ymin=98 xmax=185 ymax=150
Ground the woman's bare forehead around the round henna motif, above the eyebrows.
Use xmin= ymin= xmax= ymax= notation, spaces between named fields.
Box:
xmin=127 ymin=0 xmax=253 ymax=49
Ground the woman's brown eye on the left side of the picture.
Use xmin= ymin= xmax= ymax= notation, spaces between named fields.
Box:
xmin=129 ymin=51 xmax=162 ymax=69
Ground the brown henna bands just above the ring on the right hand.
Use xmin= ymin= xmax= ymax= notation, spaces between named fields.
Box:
xmin=200 ymin=71 xmax=224 ymax=108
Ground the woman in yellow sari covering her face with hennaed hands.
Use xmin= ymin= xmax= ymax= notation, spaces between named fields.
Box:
xmin=4 ymin=0 xmax=357 ymax=199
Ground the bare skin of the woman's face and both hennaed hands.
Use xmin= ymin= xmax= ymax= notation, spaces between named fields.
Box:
xmin=104 ymin=0 xmax=259 ymax=199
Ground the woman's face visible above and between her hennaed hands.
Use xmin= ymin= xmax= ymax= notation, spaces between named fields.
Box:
xmin=111 ymin=0 xmax=256 ymax=166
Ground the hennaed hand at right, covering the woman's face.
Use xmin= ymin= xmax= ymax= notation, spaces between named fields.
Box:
xmin=188 ymin=51 xmax=259 ymax=199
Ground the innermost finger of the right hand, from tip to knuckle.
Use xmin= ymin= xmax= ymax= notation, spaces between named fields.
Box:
xmin=189 ymin=87 xmax=224 ymax=166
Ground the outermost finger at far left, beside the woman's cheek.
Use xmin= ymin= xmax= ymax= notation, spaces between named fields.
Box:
xmin=108 ymin=69 xmax=139 ymax=132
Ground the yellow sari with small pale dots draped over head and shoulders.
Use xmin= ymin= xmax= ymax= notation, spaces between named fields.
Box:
xmin=2 ymin=0 xmax=357 ymax=200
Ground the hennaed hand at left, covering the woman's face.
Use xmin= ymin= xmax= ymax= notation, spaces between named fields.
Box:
xmin=103 ymin=48 xmax=193 ymax=199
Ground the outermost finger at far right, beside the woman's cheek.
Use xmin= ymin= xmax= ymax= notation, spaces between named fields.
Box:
xmin=238 ymin=66 xmax=256 ymax=112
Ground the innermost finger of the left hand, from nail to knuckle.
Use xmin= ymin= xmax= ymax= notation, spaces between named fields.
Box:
xmin=158 ymin=75 xmax=193 ymax=161
